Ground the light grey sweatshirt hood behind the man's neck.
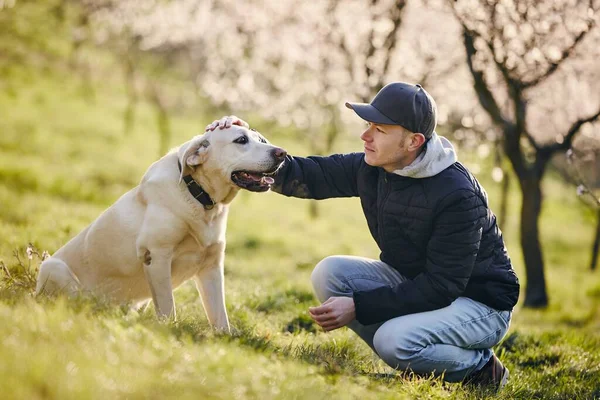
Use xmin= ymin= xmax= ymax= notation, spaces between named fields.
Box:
xmin=394 ymin=132 xmax=457 ymax=178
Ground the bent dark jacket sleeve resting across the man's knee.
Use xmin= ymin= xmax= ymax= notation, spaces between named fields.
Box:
xmin=354 ymin=189 xmax=487 ymax=325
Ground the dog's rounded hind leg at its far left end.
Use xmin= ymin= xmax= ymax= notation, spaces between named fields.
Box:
xmin=35 ymin=257 xmax=81 ymax=295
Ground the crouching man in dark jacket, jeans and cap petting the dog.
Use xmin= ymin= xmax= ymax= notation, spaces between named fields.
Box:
xmin=207 ymin=82 xmax=519 ymax=389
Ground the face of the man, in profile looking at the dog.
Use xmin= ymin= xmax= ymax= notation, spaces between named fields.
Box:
xmin=360 ymin=122 xmax=414 ymax=172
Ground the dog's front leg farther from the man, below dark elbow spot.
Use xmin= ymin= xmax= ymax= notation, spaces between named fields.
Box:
xmin=144 ymin=249 xmax=175 ymax=319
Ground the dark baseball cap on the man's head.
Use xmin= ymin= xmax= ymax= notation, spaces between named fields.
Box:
xmin=346 ymin=82 xmax=437 ymax=139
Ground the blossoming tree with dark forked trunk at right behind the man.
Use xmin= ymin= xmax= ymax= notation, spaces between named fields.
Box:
xmin=448 ymin=0 xmax=600 ymax=307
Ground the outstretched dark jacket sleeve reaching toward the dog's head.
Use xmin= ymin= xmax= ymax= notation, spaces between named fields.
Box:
xmin=271 ymin=153 xmax=364 ymax=200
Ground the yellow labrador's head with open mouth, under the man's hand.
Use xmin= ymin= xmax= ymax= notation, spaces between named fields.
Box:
xmin=179 ymin=125 xmax=287 ymax=192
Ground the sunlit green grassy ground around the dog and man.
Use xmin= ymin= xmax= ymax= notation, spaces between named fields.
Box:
xmin=0 ymin=46 xmax=600 ymax=399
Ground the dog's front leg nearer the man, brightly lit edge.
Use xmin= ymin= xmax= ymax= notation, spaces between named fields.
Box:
xmin=194 ymin=244 xmax=230 ymax=332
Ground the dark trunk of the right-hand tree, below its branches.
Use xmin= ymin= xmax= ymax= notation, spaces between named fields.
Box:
xmin=520 ymin=176 xmax=548 ymax=308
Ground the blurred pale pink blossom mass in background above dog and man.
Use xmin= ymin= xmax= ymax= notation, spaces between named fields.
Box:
xmin=81 ymin=0 xmax=472 ymax=212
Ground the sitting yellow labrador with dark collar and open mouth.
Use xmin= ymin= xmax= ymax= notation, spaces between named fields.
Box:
xmin=36 ymin=125 xmax=286 ymax=331
